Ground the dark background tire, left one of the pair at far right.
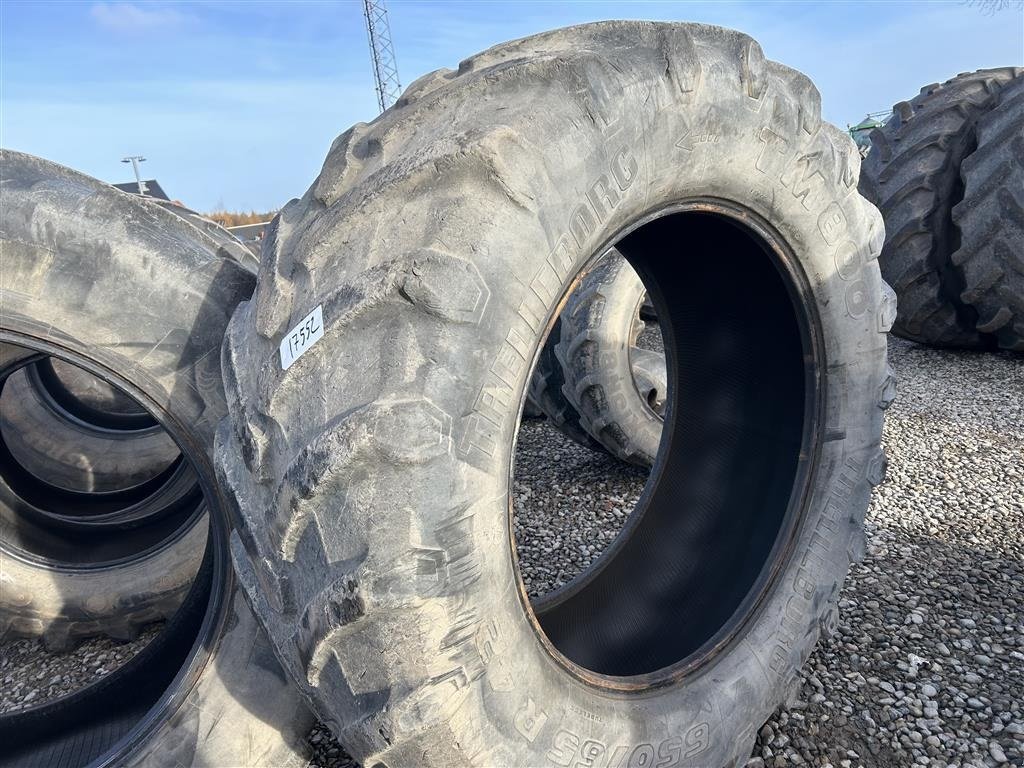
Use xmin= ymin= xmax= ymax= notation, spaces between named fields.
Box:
xmin=860 ymin=67 xmax=1022 ymax=349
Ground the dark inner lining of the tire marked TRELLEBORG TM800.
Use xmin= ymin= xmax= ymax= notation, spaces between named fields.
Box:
xmin=512 ymin=201 xmax=821 ymax=690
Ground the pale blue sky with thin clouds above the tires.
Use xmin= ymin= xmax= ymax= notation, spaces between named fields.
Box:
xmin=0 ymin=0 xmax=1024 ymax=211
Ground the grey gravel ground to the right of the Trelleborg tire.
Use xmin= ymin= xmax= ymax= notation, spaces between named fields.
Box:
xmin=748 ymin=338 xmax=1024 ymax=768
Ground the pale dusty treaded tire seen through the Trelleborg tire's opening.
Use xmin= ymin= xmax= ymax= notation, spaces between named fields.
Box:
xmin=555 ymin=253 xmax=667 ymax=467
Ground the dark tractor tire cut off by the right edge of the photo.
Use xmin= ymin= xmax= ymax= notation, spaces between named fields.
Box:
xmin=952 ymin=75 xmax=1024 ymax=352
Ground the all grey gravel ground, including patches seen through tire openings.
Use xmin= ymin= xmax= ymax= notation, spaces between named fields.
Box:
xmin=0 ymin=338 xmax=1024 ymax=768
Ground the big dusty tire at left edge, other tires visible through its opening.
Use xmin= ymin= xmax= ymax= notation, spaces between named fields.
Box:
xmin=0 ymin=151 xmax=310 ymax=768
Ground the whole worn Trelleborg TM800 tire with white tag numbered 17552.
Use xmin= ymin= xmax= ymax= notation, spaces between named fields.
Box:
xmin=217 ymin=22 xmax=896 ymax=768
